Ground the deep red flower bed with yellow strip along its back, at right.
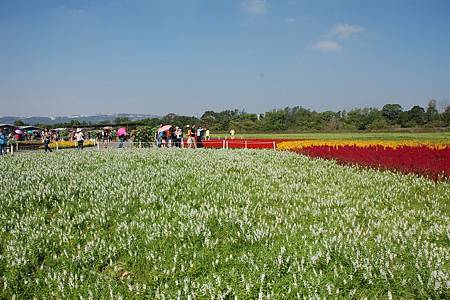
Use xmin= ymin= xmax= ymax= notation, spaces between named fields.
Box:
xmin=277 ymin=140 xmax=450 ymax=180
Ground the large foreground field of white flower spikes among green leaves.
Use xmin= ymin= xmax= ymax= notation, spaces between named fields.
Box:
xmin=0 ymin=149 xmax=450 ymax=299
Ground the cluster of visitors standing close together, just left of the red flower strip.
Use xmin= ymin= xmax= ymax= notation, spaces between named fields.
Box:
xmin=155 ymin=124 xmax=210 ymax=148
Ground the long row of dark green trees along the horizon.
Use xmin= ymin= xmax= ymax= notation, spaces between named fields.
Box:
xmin=28 ymin=100 xmax=450 ymax=132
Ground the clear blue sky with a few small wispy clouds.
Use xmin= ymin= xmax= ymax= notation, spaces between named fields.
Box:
xmin=0 ymin=0 xmax=450 ymax=116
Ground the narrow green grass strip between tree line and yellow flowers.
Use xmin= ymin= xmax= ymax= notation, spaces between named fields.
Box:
xmin=212 ymin=131 xmax=450 ymax=144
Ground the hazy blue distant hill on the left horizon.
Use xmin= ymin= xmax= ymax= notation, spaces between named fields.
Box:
xmin=0 ymin=113 xmax=160 ymax=125
